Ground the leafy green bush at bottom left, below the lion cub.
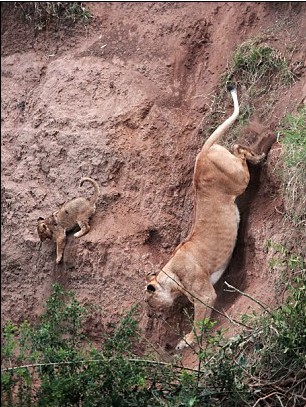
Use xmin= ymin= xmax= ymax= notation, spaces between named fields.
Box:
xmin=1 ymin=284 xmax=191 ymax=407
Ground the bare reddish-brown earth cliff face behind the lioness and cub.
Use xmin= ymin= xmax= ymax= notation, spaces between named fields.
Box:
xmin=1 ymin=2 xmax=306 ymax=364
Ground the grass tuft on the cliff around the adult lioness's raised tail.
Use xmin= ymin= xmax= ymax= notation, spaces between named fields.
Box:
xmin=199 ymin=38 xmax=295 ymax=143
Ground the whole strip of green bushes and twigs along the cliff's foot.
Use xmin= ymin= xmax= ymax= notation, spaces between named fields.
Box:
xmin=1 ymin=274 xmax=306 ymax=407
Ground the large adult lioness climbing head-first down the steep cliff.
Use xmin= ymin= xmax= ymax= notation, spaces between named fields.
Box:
xmin=146 ymin=87 xmax=265 ymax=349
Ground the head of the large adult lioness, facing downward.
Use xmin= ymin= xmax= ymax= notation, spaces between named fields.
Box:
xmin=145 ymin=274 xmax=175 ymax=317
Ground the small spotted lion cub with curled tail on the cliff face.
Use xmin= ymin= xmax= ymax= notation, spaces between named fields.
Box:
xmin=37 ymin=177 xmax=100 ymax=263
